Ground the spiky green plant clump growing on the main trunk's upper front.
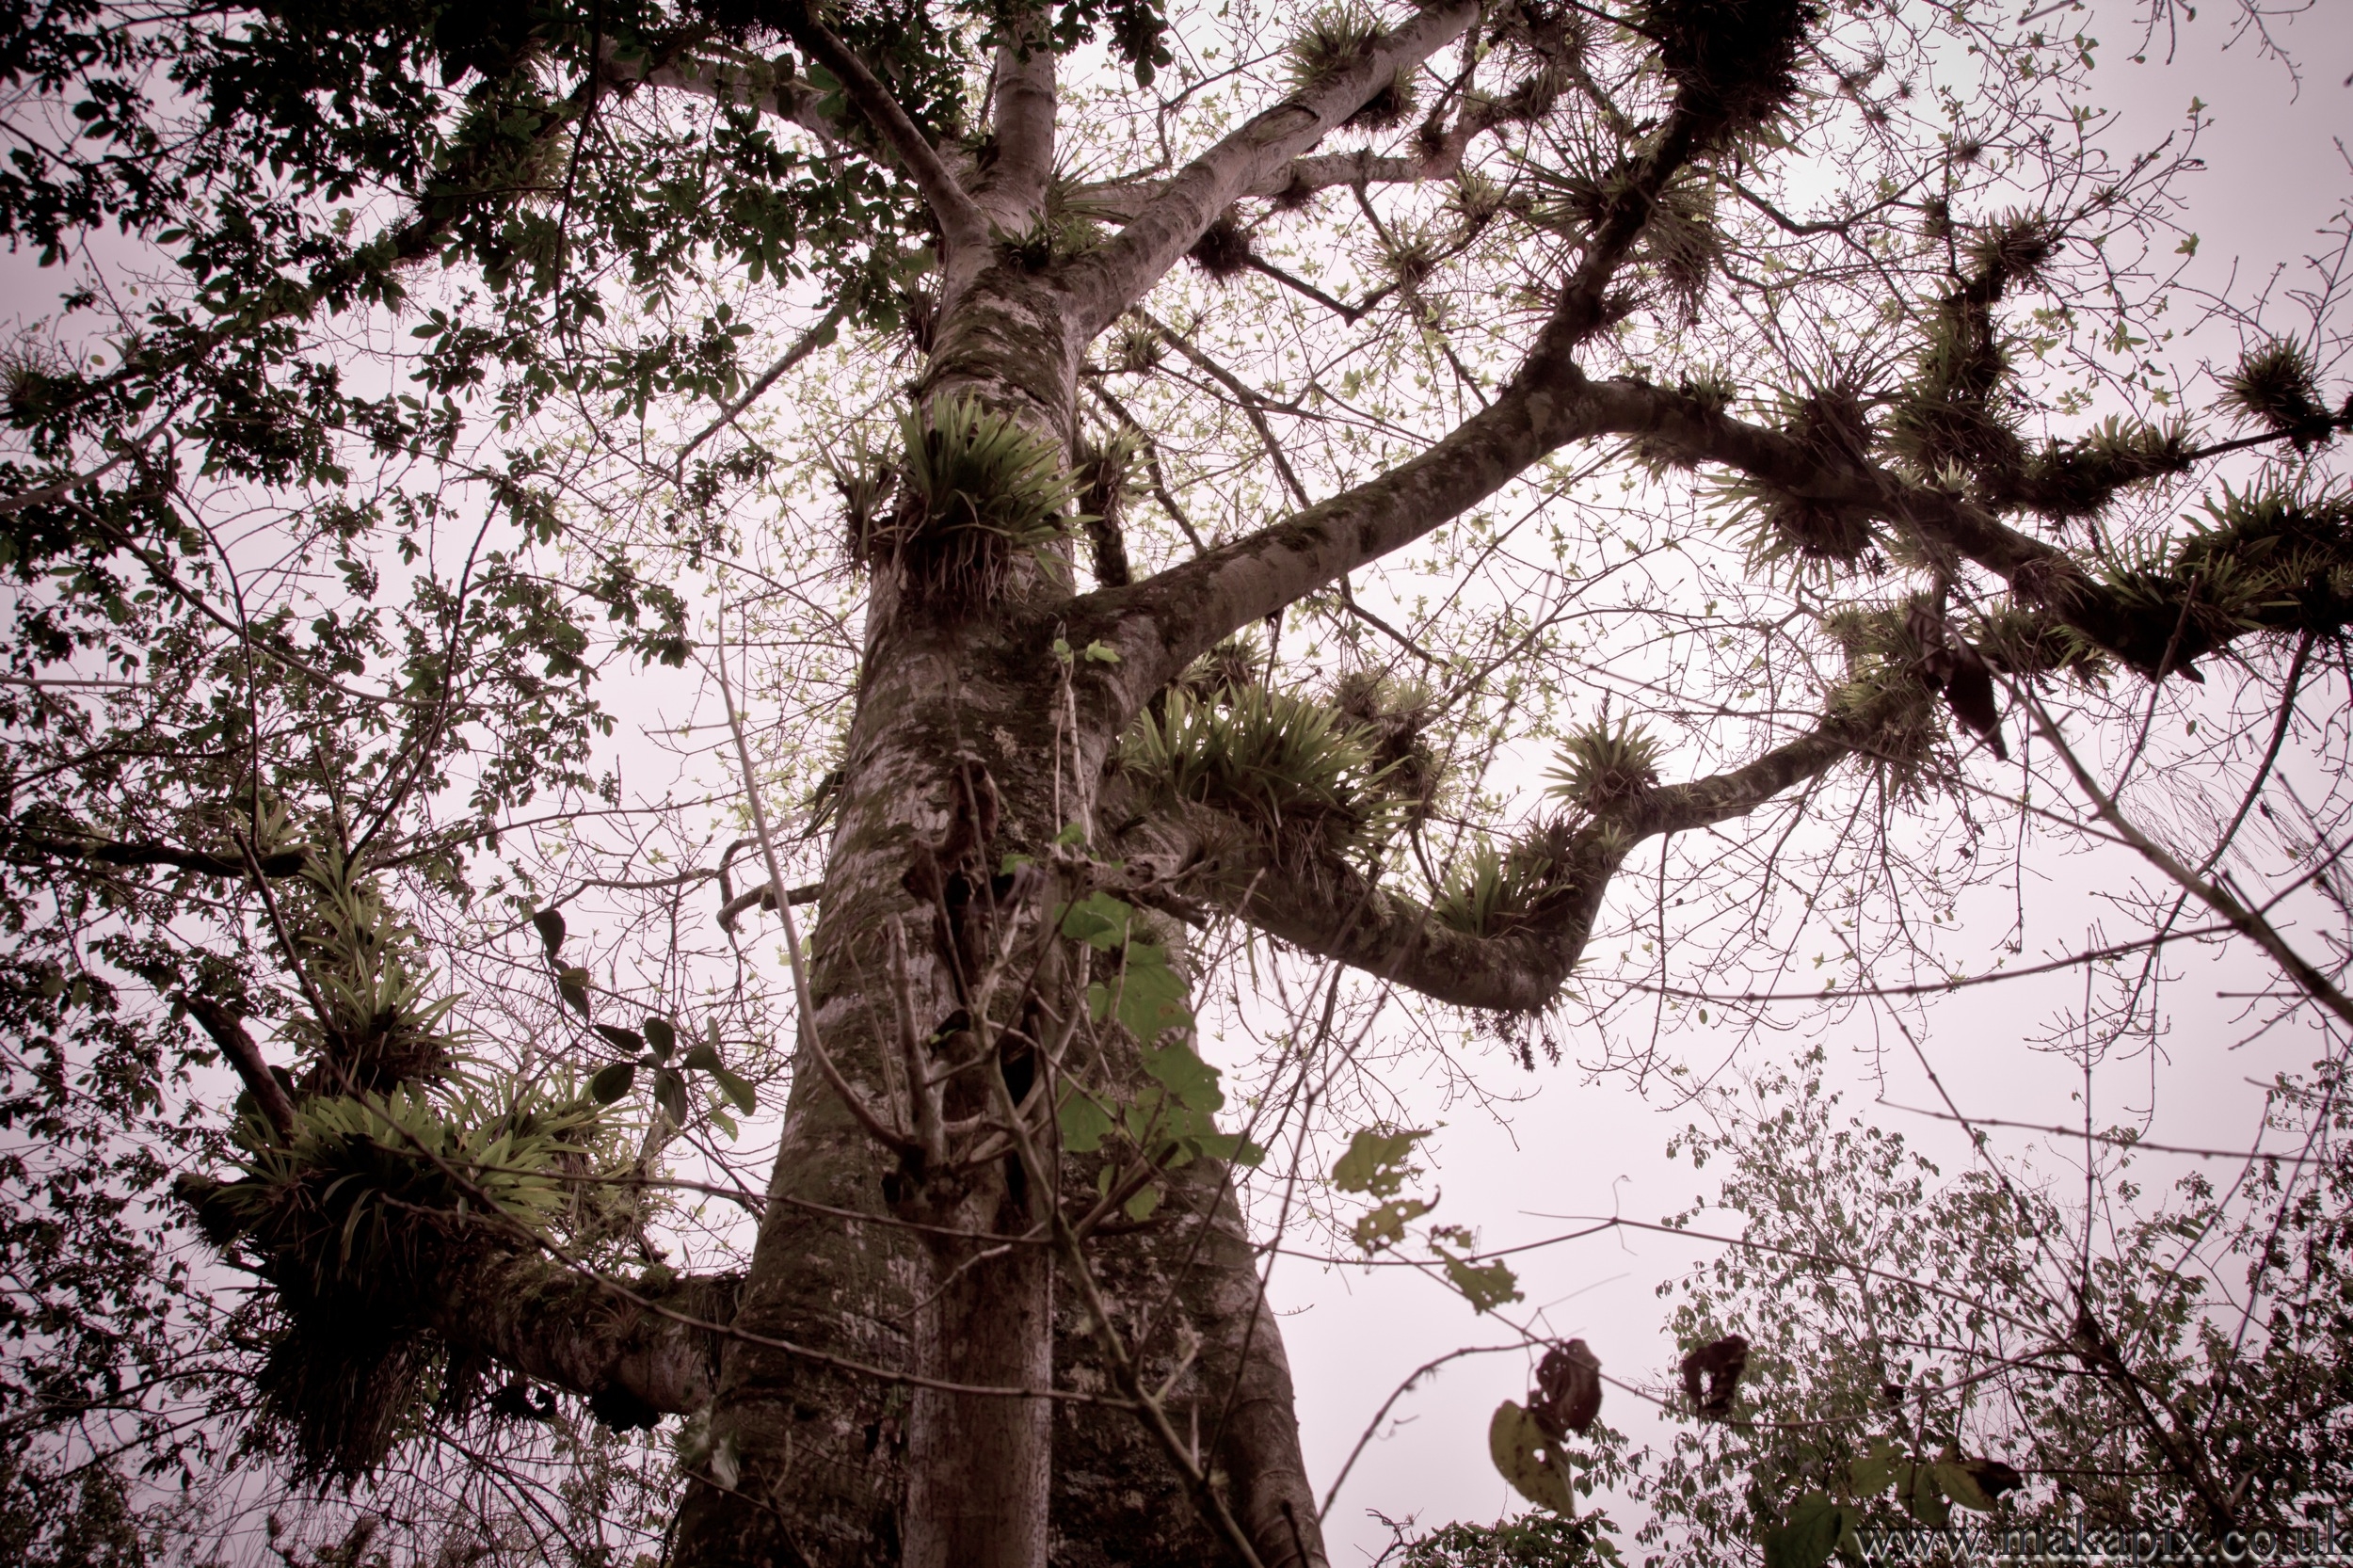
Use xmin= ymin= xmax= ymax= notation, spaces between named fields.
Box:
xmin=861 ymin=393 xmax=1085 ymax=605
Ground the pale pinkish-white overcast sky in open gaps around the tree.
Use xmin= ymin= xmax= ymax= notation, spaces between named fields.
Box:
xmin=0 ymin=0 xmax=2353 ymax=1568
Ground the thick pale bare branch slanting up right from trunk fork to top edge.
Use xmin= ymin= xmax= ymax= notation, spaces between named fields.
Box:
xmin=1064 ymin=0 xmax=1481 ymax=339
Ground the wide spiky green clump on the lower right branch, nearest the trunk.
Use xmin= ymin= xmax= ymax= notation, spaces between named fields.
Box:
xmin=1123 ymin=685 xmax=1398 ymax=855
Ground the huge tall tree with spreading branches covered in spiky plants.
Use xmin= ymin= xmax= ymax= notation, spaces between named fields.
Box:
xmin=0 ymin=0 xmax=2353 ymax=1568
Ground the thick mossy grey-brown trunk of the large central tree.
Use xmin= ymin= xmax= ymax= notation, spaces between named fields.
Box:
xmin=676 ymin=264 xmax=1321 ymax=1568
